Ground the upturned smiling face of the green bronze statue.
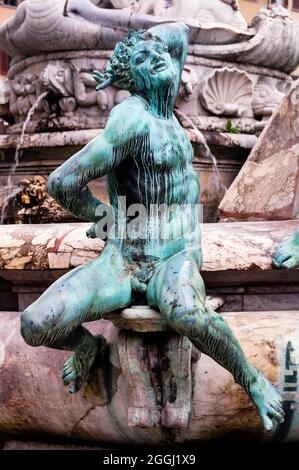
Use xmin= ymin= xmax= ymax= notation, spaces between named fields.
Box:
xmin=130 ymin=40 xmax=175 ymax=93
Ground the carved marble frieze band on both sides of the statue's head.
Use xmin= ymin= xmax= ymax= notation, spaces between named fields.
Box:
xmin=0 ymin=51 xmax=290 ymax=134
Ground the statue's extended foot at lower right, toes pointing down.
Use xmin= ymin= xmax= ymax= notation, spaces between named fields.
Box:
xmin=249 ymin=371 xmax=284 ymax=432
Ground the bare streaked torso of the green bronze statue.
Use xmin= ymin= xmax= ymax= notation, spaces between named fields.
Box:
xmin=108 ymin=97 xmax=199 ymax=258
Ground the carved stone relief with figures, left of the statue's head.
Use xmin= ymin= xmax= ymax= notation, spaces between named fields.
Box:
xmin=8 ymin=54 xmax=128 ymax=133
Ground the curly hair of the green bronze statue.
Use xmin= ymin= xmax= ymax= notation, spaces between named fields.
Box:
xmin=94 ymin=30 xmax=168 ymax=91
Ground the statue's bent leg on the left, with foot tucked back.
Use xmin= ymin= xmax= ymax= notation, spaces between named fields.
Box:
xmin=21 ymin=245 xmax=131 ymax=393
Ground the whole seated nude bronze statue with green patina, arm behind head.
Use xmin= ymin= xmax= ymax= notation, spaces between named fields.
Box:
xmin=22 ymin=23 xmax=284 ymax=430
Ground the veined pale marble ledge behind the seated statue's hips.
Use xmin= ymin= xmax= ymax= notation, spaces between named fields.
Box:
xmin=0 ymin=220 xmax=299 ymax=274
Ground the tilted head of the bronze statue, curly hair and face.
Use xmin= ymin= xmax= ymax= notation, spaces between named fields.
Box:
xmin=94 ymin=30 xmax=175 ymax=94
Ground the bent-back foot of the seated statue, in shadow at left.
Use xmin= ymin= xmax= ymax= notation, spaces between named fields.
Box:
xmin=62 ymin=337 xmax=106 ymax=394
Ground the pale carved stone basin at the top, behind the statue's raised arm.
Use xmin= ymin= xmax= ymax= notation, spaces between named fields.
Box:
xmin=0 ymin=0 xmax=299 ymax=73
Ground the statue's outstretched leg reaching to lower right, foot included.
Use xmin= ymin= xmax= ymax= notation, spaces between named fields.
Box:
xmin=147 ymin=252 xmax=284 ymax=431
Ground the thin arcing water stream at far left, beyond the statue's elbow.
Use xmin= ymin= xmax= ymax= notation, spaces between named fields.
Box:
xmin=0 ymin=91 xmax=48 ymax=225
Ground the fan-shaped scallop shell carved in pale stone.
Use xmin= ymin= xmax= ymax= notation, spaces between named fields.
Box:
xmin=201 ymin=67 xmax=253 ymax=116
